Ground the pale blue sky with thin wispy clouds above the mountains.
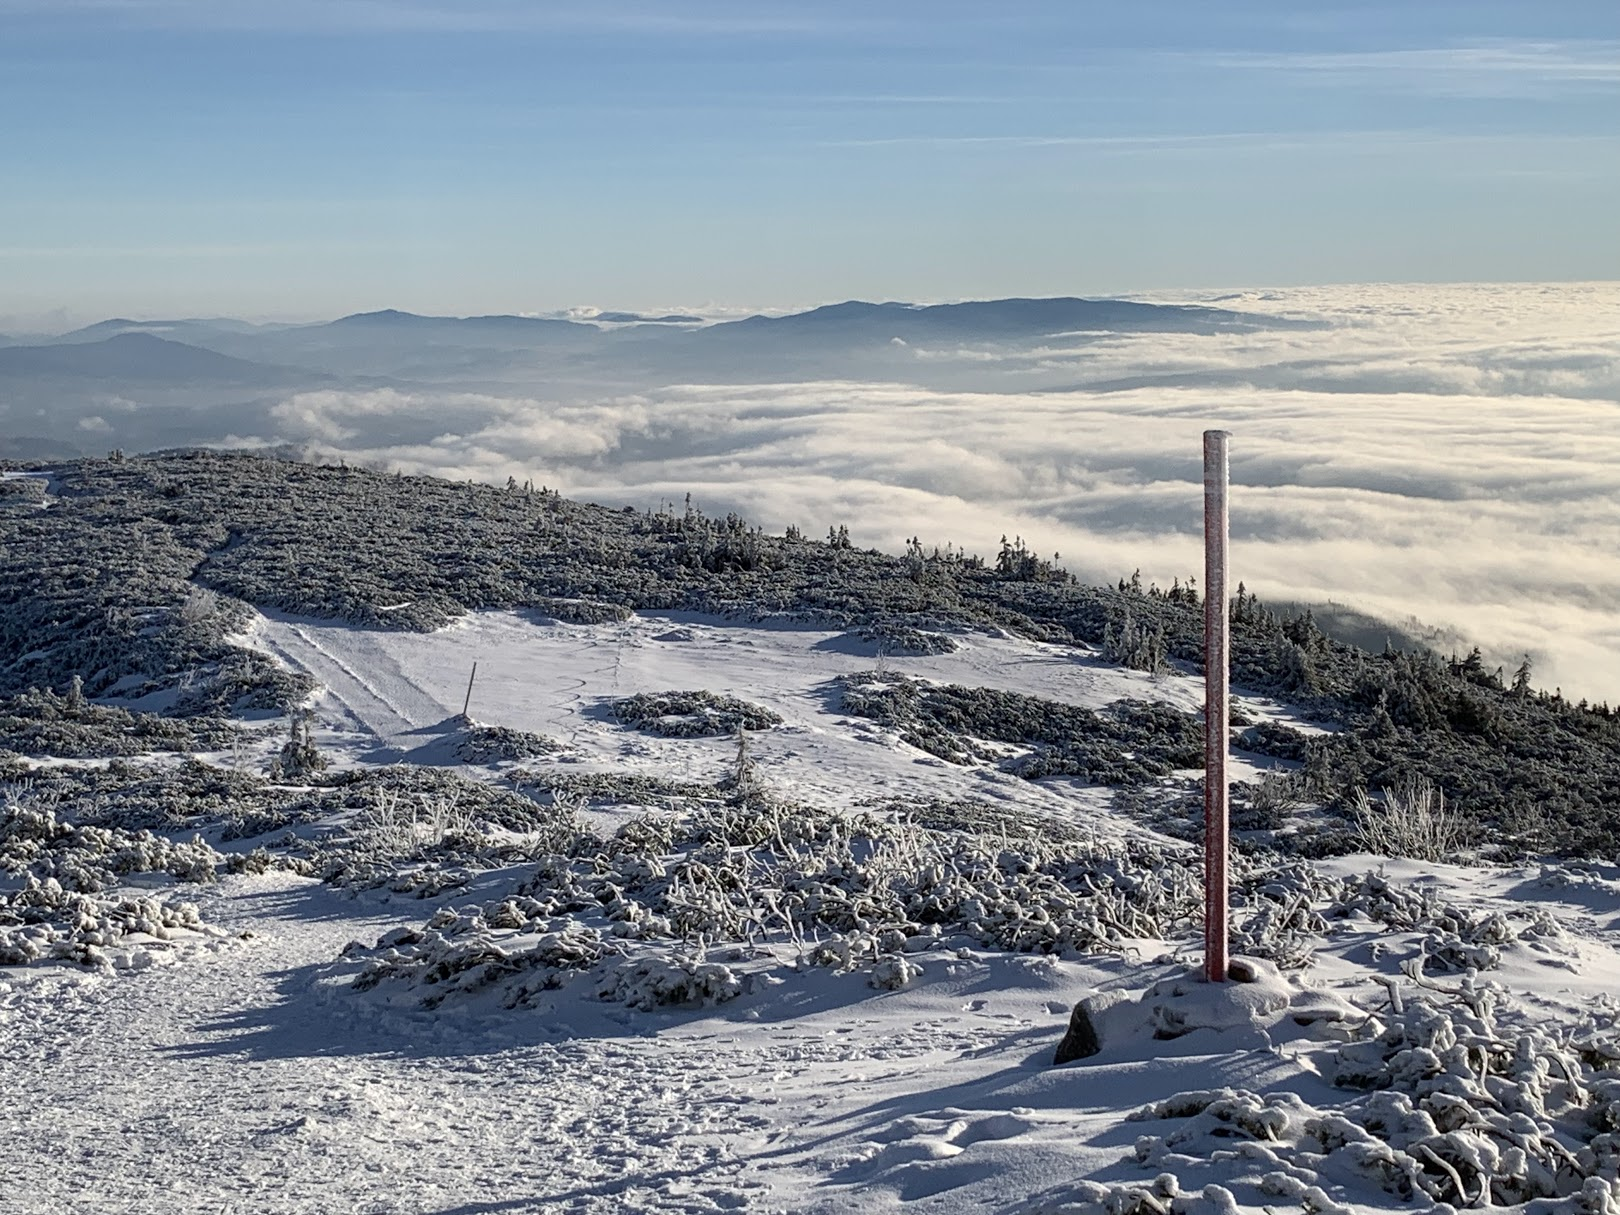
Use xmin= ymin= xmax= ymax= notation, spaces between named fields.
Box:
xmin=0 ymin=0 xmax=1620 ymax=321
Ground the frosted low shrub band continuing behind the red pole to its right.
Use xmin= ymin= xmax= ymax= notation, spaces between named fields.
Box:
xmin=335 ymin=786 xmax=1412 ymax=1006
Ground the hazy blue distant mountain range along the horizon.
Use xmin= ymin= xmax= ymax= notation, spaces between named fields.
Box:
xmin=0 ymin=296 xmax=1298 ymax=409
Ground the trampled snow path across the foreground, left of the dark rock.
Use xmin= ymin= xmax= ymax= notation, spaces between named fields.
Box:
xmin=0 ymin=873 xmax=1114 ymax=1215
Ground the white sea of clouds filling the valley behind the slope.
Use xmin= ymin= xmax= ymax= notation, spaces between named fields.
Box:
xmin=272 ymin=284 xmax=1620 ymax=701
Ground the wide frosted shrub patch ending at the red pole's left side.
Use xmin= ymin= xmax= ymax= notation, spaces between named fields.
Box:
xmin=341 ymin=789 xmax=1200 ymax=1010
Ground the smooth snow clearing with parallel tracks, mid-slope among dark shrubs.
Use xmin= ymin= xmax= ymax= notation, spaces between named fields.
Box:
xmin=243 ymin=612 xmax=1311 ymax=826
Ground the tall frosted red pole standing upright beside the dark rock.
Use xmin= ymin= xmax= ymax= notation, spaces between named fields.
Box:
xmin=1204 ymin=431 xmax=1231 ymax=983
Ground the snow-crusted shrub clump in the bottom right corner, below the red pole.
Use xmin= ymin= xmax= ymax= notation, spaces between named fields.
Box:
xmin=1101 ymin=980 xmax=1620 ymax=1215
